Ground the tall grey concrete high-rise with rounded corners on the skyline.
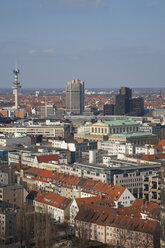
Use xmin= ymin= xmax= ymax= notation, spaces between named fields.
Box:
xmin=66 ymin=80 xmax=84 ymax=115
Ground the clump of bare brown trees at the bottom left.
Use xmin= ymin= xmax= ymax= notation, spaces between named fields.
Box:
xmin=17 ymin=204 xmax=57 ymax=248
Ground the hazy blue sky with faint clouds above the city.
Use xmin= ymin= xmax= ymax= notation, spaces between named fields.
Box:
xmin=0 ymin=0 xmax=165 ymax=88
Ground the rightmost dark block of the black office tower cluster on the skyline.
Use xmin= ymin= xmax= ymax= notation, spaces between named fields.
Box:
xmin=130 ymin=97 xmax=144 ymax=116
